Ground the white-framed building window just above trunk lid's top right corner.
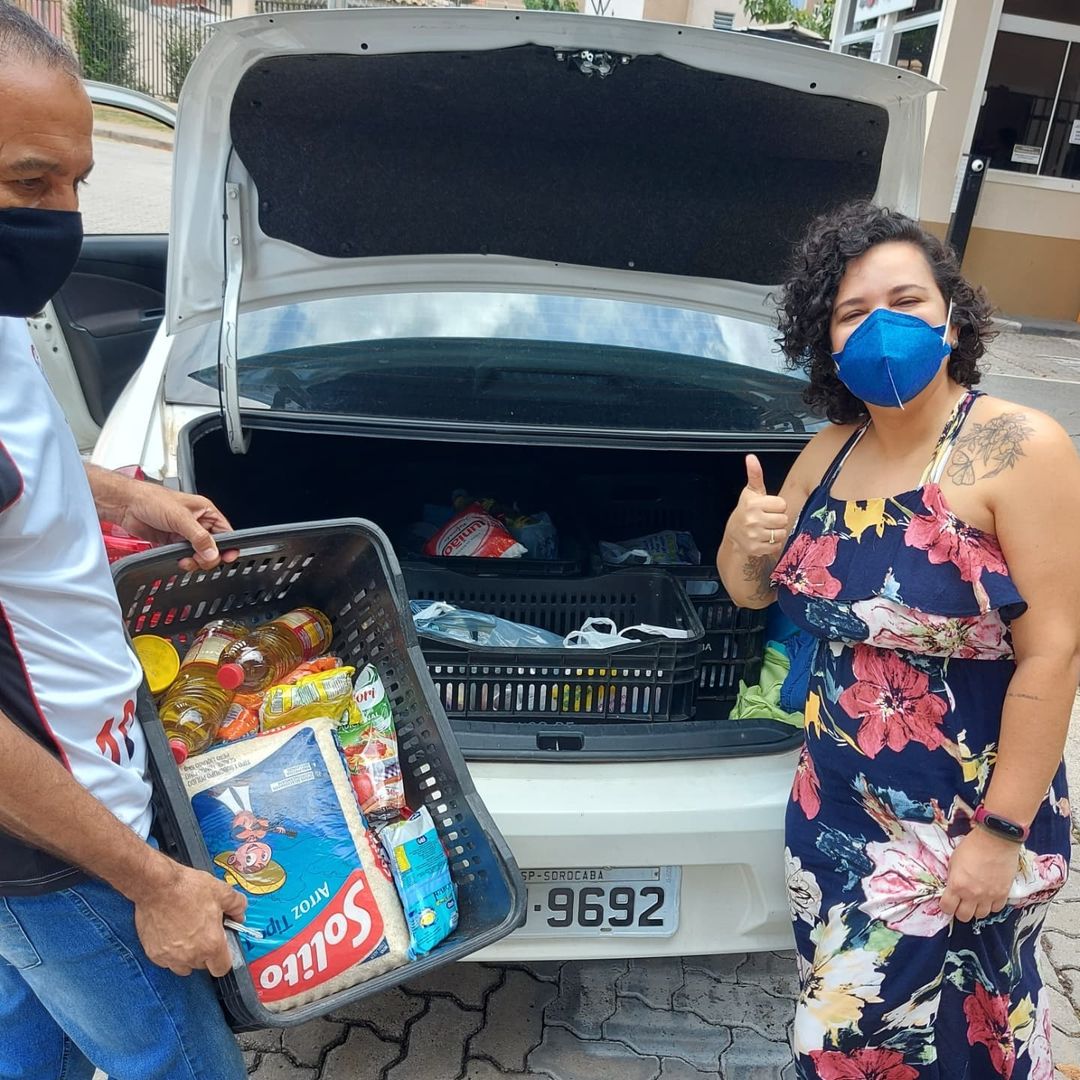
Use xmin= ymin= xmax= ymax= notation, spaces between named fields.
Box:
xmin=833 ymin=0 xmax=944 ymax=75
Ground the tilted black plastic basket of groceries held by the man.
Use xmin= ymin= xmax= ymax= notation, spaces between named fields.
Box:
xmin=112 ymin=519 xmax=525 ymax=1030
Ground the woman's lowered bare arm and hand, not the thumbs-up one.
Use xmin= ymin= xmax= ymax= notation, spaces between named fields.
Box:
xmin=942 ymin=410 xmax=1080 ymax=920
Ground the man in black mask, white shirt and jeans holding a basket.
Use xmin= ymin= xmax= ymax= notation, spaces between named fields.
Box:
xmin=0 ymin=8 xmax=245 ymax=1080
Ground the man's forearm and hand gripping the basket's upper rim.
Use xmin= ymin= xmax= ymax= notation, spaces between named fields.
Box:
xmin=86 ymin=465 xmax=238 ymax=571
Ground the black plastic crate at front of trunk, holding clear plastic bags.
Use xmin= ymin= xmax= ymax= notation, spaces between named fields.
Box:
xmin=405 ymin=567 xmax=704 ymax=724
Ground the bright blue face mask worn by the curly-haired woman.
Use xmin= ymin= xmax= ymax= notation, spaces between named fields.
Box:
xmin=833 ymin=301 xmax=953 ymax=408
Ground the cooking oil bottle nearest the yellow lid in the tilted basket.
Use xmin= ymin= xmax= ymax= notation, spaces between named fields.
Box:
xmin=159 ymin=619 xmax=247 ymax=764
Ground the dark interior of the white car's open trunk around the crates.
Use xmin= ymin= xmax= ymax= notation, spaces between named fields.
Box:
xmin=180 ymin=417 xmax=801 ymax=761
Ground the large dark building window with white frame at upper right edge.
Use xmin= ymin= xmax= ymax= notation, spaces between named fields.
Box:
xmin=972 ymin=18 xmax=1080 ymax=180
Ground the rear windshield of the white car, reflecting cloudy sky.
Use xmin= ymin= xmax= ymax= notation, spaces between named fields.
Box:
xmin=165 ymin=293 xmax=819 ymax=433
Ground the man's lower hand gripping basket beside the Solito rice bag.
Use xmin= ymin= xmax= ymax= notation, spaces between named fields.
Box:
xmin=133 ymin=855 xmax=247 ymax=978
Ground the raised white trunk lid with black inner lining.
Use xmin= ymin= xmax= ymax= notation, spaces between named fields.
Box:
xmin=166 ymin=9 xmax=934 ymax=332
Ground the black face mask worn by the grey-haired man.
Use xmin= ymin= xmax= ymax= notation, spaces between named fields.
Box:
xmin=0 ymin=206 xmax=82 ymax=319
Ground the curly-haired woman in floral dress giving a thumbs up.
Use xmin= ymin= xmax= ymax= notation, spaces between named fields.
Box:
xmin=717 ymin=203 xmax=1080 ymax=1080
